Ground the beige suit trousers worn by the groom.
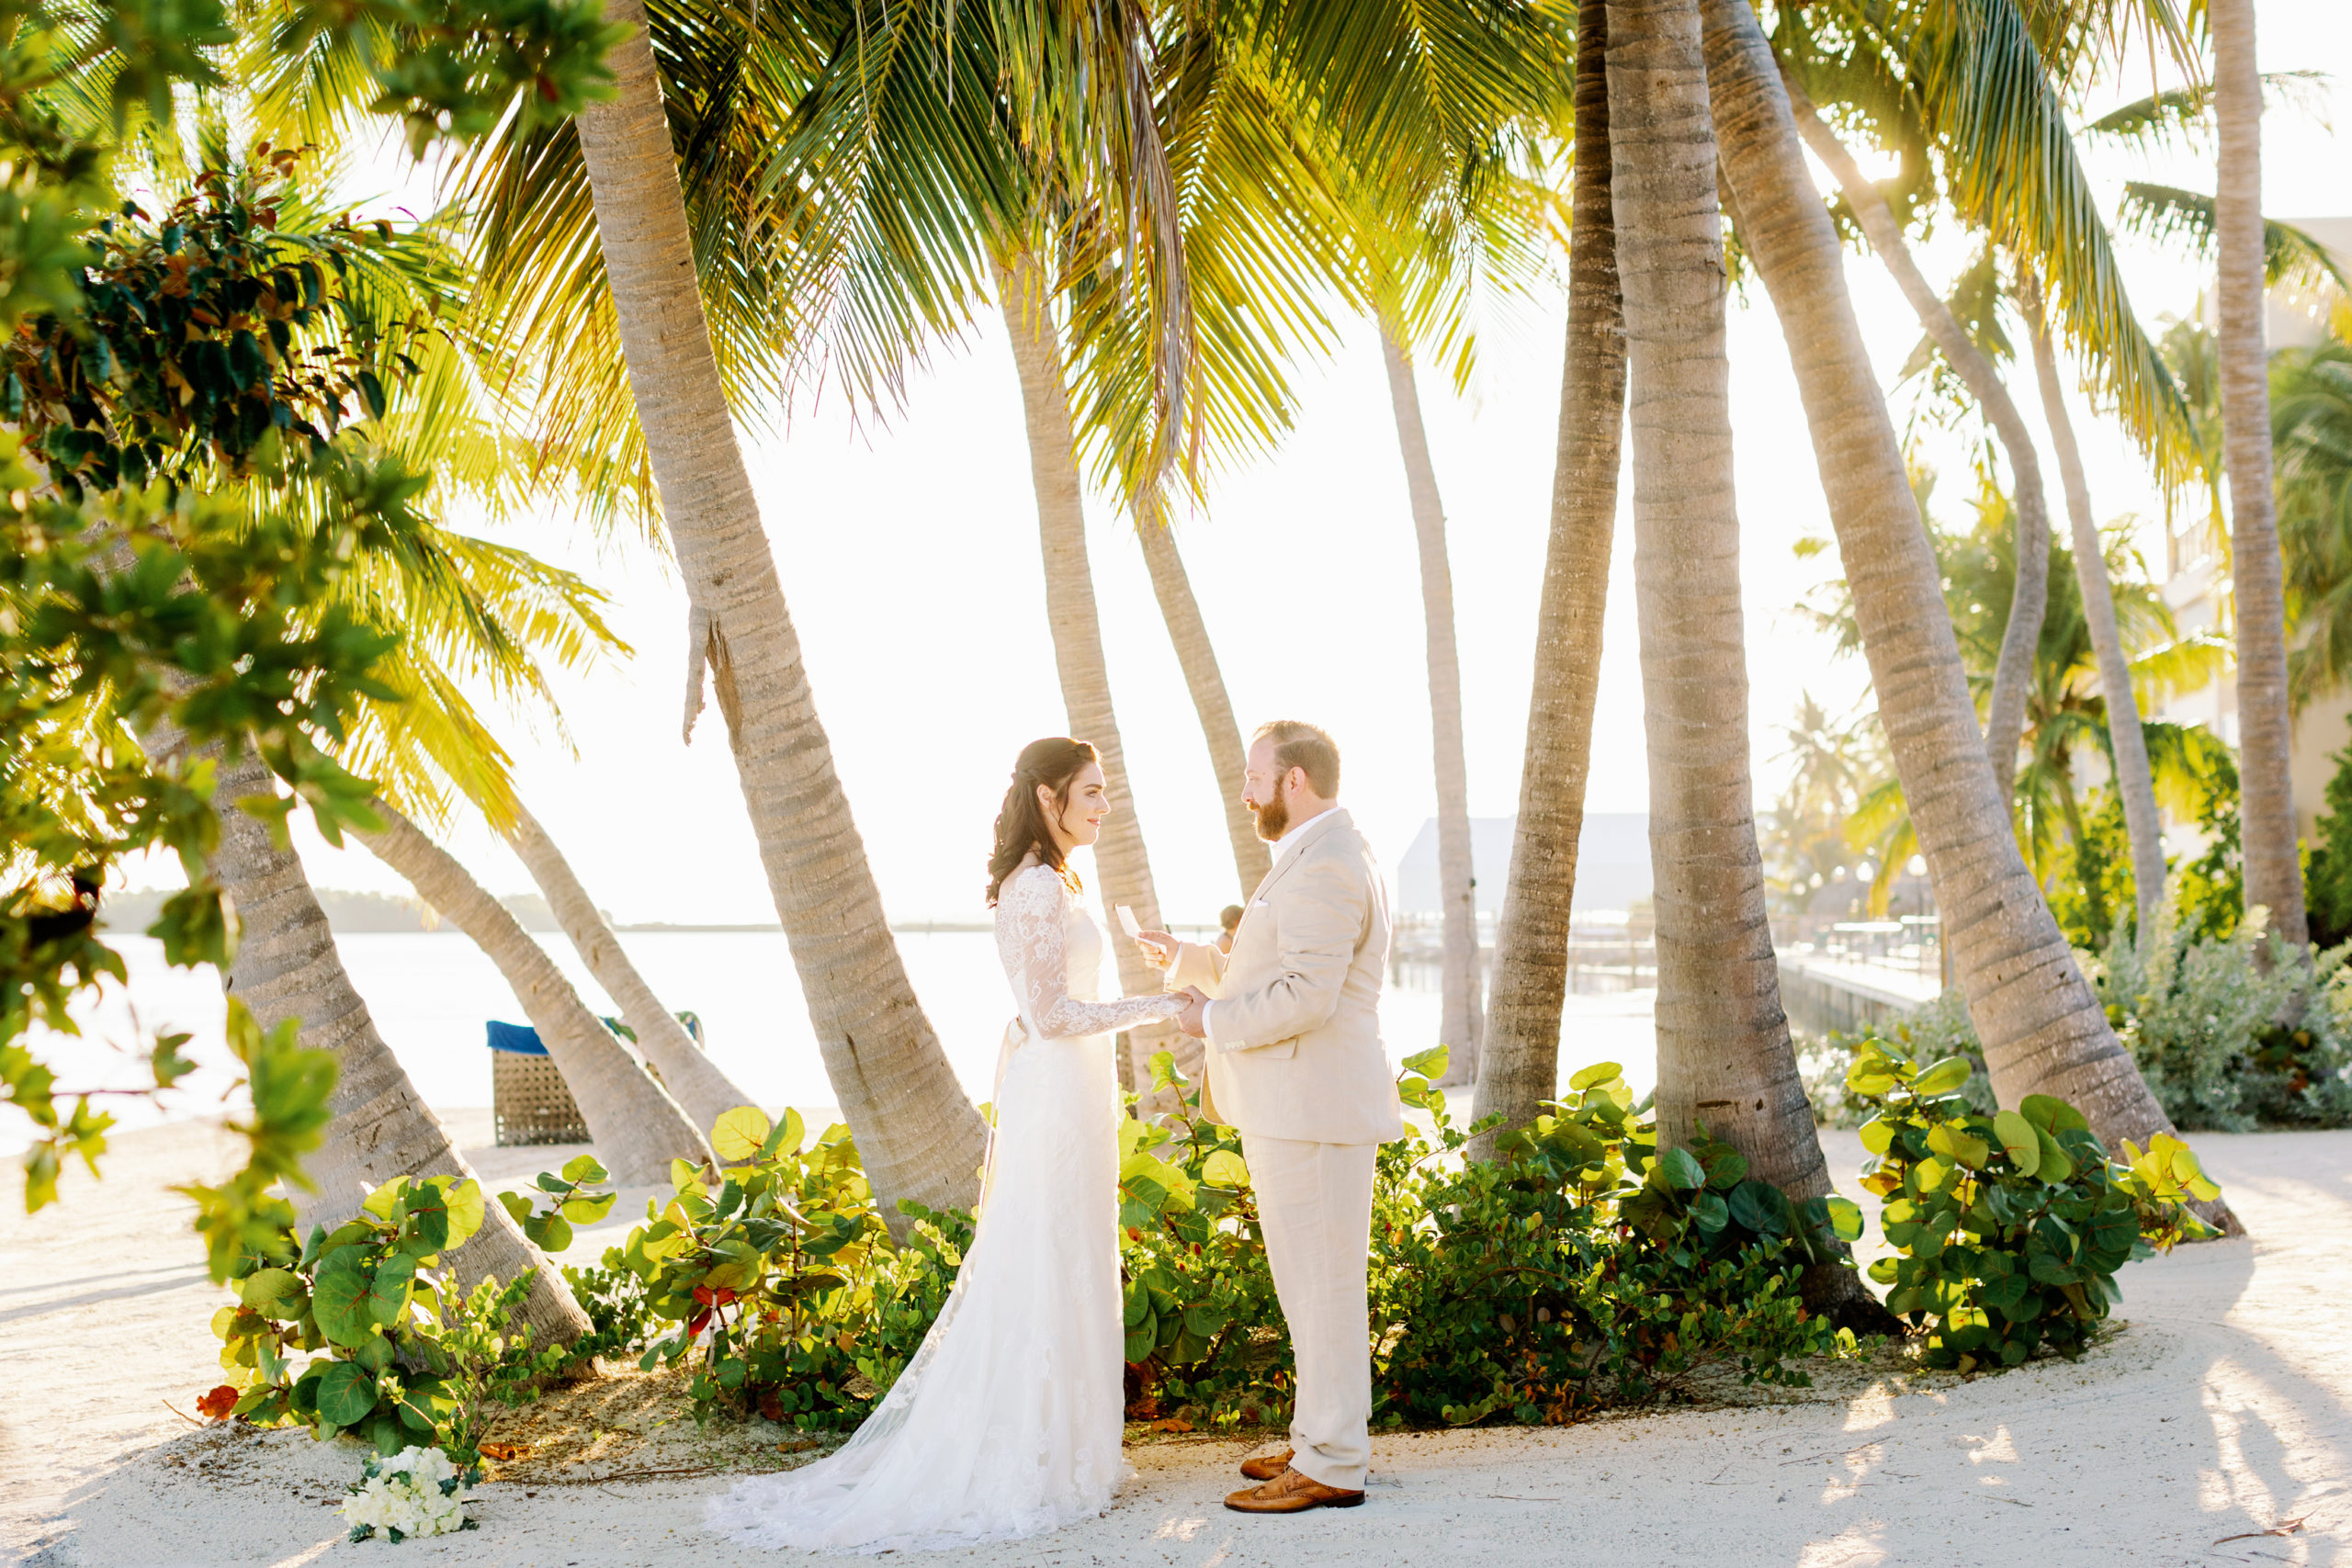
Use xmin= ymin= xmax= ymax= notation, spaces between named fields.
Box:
xmin=1242 ymin=1131 xmax=1381 ymax=1491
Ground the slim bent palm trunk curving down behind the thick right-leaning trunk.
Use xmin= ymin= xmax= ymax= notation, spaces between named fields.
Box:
xmin=1785 ymin=83 xmax=2051 ymax=799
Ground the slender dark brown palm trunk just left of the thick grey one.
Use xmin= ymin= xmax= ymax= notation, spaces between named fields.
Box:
xmin=1473 ymin=0 xmax=1625 ymax=1159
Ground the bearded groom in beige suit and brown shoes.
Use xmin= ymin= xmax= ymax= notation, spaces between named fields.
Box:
xmin=1141 ymin=719 xmax=1404 ymax=1514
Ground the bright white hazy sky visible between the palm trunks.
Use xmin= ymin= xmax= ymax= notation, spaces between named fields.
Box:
xmin=202 ymin=0 xmax=2352 ymax=921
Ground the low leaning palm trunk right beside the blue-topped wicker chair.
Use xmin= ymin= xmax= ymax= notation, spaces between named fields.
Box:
xmin=360 ymin=799 xmax=710 ymax=1187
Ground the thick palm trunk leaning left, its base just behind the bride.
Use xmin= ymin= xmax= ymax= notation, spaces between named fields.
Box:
xmin=579 ymin=0 xmax=988 ymax=1224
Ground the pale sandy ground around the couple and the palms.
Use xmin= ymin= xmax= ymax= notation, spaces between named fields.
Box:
xmin=0 ymin=1112 xmax=2352 ymax=1568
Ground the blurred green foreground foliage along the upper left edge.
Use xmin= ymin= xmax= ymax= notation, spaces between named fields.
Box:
xmin=0 ymin=0 xmax=618 ymax=1222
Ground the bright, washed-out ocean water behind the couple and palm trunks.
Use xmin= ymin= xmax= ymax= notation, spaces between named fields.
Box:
xmin=0 ymin=931 xmax=1656 ymax=1149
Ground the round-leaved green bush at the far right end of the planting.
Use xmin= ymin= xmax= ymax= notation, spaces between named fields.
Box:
xmin=1847 ymin=1039 xmax=2221 ymax=1373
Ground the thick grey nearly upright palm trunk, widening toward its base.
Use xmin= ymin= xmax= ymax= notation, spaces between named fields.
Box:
xmin=1609 ymin=0 xmax=1884 ymax=1321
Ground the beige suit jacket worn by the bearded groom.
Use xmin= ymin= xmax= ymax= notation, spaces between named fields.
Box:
xmin=1169 ymin=811 xmax=1404 ymax=1143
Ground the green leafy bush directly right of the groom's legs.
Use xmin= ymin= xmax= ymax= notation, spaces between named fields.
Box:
xmin=1371 ymin=1051 xmax=1860 ymax=1425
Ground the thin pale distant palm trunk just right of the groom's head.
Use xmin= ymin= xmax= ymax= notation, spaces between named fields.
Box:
xmin=1381 ymin=317 xmax=1484 ymax=1086
